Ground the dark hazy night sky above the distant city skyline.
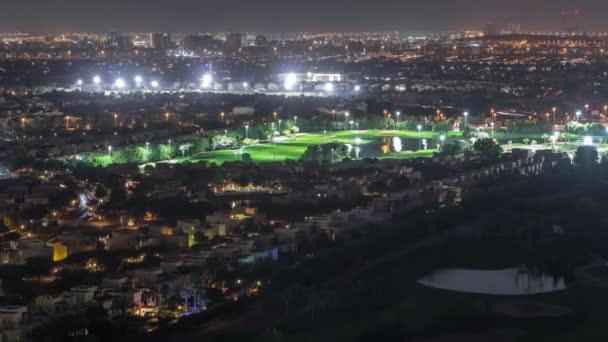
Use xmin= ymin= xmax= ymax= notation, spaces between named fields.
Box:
xmin=0 ymin=0 xmax=608 ymax=32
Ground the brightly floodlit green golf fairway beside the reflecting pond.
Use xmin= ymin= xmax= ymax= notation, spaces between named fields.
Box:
xmin=180 ymin=130 xmax=462 ymax=164
